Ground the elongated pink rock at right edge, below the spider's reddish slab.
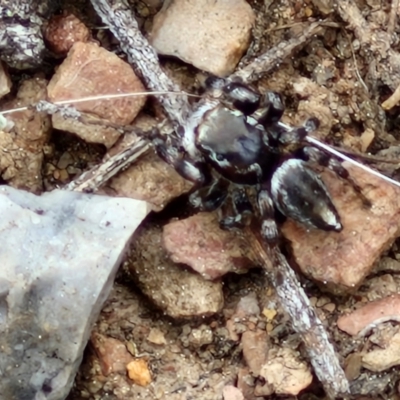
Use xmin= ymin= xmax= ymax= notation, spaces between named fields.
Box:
xmin=337 ymin=295 xmax=400 ymax=336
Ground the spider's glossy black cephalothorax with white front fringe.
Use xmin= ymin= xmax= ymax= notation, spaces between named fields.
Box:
xmin=196 ymin=107 xmax=265 ymax=185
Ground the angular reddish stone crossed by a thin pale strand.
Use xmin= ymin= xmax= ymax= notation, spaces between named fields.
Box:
xmin=47 ymin=42 xmax=146 ymax=125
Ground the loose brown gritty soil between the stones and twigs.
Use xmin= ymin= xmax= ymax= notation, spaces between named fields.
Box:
xmin=3 ymin=0 xmax=400 ymax=400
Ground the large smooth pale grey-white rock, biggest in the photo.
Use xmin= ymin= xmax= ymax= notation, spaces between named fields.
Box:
xmin=0 ymin=186 xmax=147 ymax=400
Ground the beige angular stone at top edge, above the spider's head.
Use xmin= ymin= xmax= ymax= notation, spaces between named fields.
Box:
xmin=149 ymin=0 xmax=255 ymax=77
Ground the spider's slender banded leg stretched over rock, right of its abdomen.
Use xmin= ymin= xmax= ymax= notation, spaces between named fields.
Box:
xmin=302 ymin=146 xmax=371 ymax=207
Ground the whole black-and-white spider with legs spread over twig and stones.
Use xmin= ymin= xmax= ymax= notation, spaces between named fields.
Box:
xmin=155 ymin=80 xmax=354 ymax=243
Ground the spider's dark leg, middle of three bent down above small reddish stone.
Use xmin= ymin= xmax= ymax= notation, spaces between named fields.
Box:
xmin=219 ymin=188 xmax=253 ymax=230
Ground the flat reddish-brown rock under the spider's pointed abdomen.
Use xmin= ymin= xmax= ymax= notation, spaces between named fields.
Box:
xmin=282 ymin=163 xmax=400 ymax=294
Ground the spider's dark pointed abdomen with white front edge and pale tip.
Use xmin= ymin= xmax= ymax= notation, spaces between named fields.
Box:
xmin=271 ymin=158 xmax=342 ymax=232
